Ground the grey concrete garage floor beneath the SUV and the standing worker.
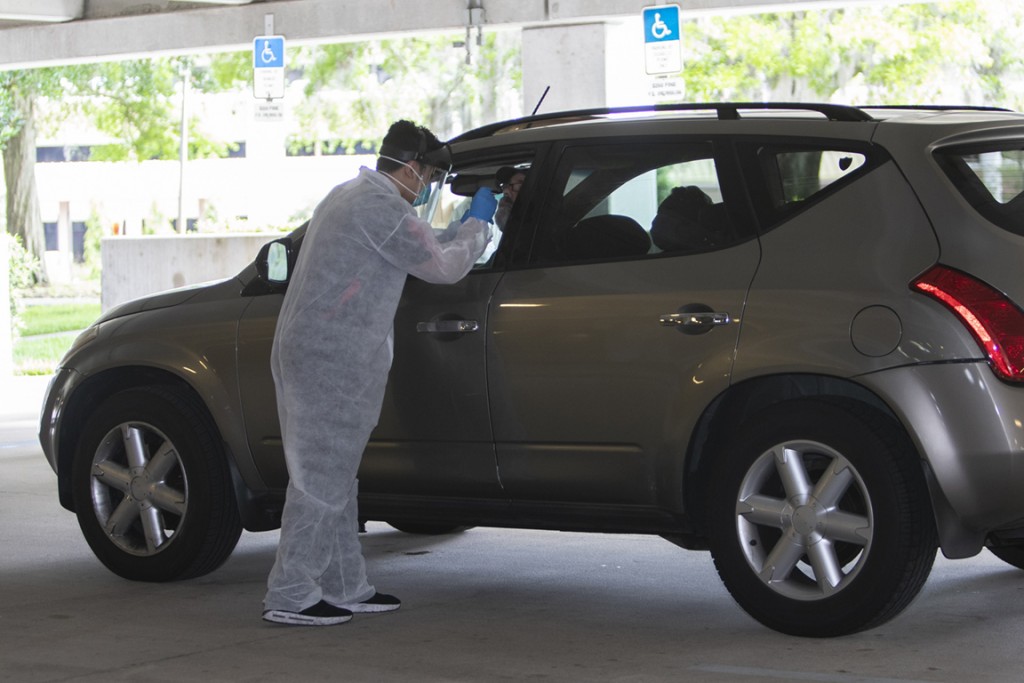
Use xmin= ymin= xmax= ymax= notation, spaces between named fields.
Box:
xmin=0 ymin=378 xmax=1024 ymax=683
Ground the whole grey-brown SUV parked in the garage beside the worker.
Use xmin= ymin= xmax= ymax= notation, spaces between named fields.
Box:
xmin=41 ymin=103 xmax=1024 ymax=636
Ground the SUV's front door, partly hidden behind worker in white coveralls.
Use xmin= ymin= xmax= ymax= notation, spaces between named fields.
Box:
xmin=239 ymin=150 xmax=532 ymax=520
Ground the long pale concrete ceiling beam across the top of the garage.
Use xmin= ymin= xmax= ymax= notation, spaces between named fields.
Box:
xmin=0 ymin=0 xmax=864 ymax=70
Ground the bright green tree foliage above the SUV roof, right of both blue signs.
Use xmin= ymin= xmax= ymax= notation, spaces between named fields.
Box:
xmin=681 ymin=0 xmax=1024 ymax=109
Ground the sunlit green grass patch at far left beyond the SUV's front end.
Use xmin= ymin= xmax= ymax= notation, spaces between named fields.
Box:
xmin=14 ymin=303 xmax=99 ymax=375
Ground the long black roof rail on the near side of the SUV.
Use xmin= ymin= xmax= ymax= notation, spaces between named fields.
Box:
xmin=450 ymin=102 xmax=874 ymax=142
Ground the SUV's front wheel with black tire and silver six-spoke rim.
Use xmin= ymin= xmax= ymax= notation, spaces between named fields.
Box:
xmin=72 ymin=388 xmax=242 ymax=582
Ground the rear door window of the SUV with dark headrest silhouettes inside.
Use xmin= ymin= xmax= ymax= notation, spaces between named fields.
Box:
xmin=536 ymin=141 xmax=736 ymax=263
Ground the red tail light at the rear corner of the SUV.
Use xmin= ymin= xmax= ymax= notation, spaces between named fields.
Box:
xmin=910 ymin=265 xmax=1024 ymax=382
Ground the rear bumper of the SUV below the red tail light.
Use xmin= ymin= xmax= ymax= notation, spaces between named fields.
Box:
xmin=860 ymin=361 xmax=1024 ymax=557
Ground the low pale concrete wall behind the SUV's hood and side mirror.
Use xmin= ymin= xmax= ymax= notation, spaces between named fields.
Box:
xmin=100 ymin=232 xmax=281 ymax=311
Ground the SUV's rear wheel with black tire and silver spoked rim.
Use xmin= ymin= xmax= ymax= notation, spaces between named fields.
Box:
xmin=708 ymin=399 xmax=938 ymax=637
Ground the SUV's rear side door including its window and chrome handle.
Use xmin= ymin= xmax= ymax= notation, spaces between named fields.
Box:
xmin=487 ymin=137 xmax=760 ymax=518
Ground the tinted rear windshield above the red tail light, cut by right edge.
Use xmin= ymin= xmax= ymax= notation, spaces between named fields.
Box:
xmin=937 ymin=142 xmax=1024 ymax=234
